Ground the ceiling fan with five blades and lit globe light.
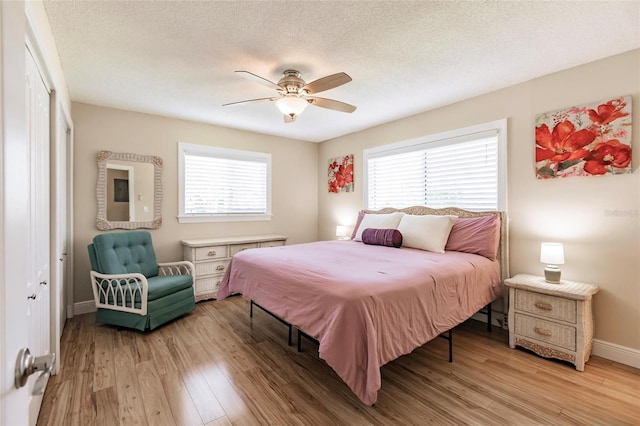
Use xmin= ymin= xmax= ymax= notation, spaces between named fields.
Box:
xmin=222 ymin=70 xmax=356 ymax=123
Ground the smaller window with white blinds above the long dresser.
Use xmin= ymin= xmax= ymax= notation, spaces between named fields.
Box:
xmin=178 ymin=143 xmax=271 ymax=223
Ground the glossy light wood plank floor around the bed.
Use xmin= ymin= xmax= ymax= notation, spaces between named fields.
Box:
xmin=38 ymin=297 xmax=640 ymax=426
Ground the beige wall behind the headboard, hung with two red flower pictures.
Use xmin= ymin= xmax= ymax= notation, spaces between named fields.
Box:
xmin=318 ymin=50 xmax=640 ymax=349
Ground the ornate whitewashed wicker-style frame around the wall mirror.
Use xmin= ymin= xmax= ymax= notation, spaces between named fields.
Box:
xmin=96 ymin=151 xmax=162 ymax=231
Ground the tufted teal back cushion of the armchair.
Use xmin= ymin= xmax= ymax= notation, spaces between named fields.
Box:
xmin=93 ymin=231 xmax=160 ymax=278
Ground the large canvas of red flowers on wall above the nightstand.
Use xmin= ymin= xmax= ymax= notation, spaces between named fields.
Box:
xmin=536 ymin=96 xmax=631 ymax=179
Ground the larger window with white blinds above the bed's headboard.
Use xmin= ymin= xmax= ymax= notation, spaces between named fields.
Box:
xmin=364 ymin=120 xmax=507 ymax=211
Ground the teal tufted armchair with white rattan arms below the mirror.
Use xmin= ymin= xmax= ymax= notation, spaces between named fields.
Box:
xmin=88 ymin=231 xmax=196 ymax=331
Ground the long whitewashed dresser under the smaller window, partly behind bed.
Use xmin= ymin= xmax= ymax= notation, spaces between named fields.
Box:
xmin=181 ymin=235 xmax=287 ymax=302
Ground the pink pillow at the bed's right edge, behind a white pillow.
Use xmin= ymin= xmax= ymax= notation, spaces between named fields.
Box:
xmin=444 ymin=214 xmax=500 ymax=260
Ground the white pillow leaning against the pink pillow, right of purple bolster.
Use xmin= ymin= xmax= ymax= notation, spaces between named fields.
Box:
xmin=398 ymin=214 xmax=458 ymax=253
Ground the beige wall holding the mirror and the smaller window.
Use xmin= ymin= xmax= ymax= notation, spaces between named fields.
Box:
xmin=72 ymin=103 xmax=318 ymax=303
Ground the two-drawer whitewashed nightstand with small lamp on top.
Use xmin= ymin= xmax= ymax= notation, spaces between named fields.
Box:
xmin=504 ymin=274 xmax=598 ymax=371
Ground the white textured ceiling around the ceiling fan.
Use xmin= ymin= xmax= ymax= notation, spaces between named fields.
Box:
xmin=44 ymin=0 xmax=640 ymax=142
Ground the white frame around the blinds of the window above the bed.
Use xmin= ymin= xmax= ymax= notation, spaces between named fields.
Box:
xmin=362 ymin=118 xmax=507 ymax=212
